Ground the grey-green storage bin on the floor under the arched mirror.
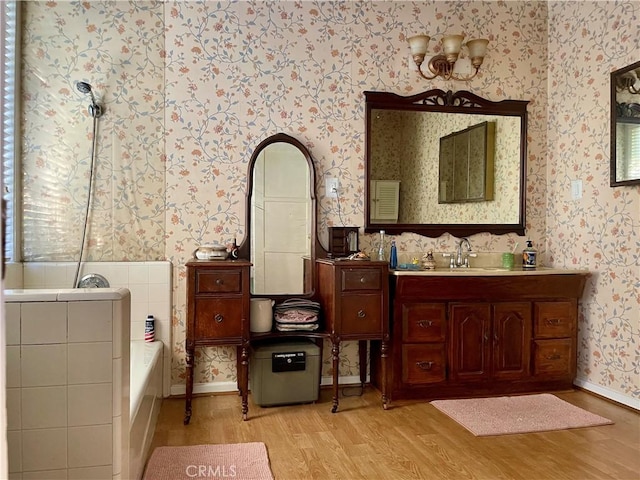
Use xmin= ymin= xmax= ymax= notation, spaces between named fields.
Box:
xmin=249 ymin=340 xmax=322 ymax=407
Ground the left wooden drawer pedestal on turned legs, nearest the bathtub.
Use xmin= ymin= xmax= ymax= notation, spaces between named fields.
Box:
xmin=184 ymin=260 xmax=251 ymax=425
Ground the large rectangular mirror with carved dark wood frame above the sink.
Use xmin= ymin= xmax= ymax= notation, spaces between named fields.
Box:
xmin=364 ymin=90 xmax=528 ymax=237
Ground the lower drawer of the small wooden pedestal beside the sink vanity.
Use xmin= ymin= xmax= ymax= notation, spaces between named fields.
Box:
xmin=340 ymin=293 xmax=383 ymax=335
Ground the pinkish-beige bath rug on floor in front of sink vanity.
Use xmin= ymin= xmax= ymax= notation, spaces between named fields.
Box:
xmin=431 ymin=393 xmax=613 ymax=437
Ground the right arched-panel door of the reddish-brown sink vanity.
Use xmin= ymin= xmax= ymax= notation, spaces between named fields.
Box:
xmin=491 ymin=302 xmax=531 ymax=379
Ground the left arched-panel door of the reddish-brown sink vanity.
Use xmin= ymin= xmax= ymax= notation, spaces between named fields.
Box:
xmin=449 ymin=303 xmax=491 ymax=380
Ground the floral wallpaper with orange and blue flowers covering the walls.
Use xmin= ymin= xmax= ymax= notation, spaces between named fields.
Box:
xmin=17 ymin=0 xmax=640 ymax=399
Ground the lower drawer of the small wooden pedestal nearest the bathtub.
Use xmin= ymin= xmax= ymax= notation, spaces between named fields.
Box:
xmin=194 ymin=298 xmax=243 ymax=342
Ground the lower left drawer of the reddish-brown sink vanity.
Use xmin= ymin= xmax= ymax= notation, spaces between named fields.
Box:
xmin=402 ymin=343 xmax=447 ymax=384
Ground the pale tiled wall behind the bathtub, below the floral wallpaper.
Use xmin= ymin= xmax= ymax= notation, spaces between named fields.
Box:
xmin=5 ymin=261 xmax=171 ymax=397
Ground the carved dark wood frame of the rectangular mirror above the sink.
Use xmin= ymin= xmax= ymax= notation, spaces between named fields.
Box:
xmin=364 ymin=89 xmax=529 ymax=237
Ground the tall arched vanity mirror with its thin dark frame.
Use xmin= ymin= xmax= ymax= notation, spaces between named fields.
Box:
xmin=239 ymin=133 xmax=317 ymax=298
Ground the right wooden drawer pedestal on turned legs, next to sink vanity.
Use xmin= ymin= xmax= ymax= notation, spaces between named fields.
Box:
xmin=316 ymin=259 xmax=389 ymax=413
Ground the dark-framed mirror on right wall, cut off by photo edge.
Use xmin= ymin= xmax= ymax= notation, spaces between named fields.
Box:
xmin=610 ymin=62 xmax=640 ymax=187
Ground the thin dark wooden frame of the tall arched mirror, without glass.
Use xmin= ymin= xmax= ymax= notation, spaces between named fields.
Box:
xmin=238 ymin=133 xmax=324 ymax=302
